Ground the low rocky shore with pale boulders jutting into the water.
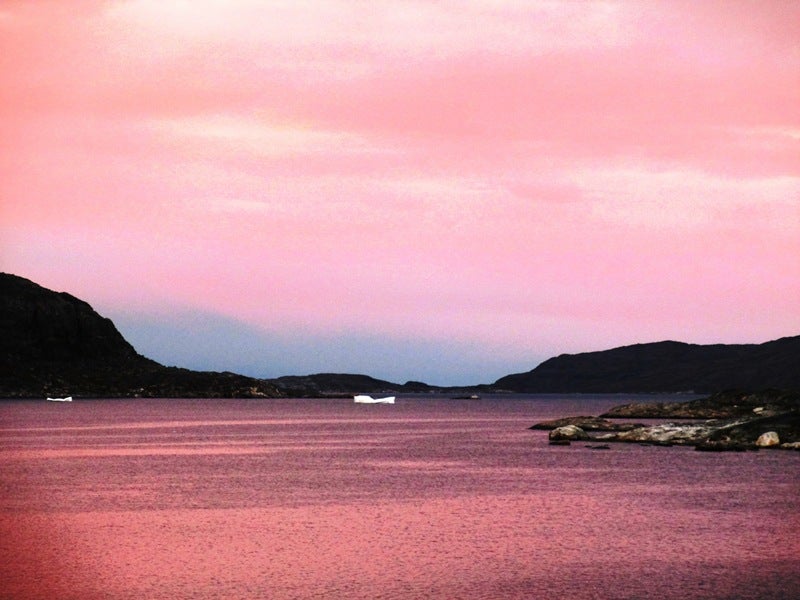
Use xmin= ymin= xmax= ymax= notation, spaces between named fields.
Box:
xmin=531 ymin=390 xmax=800 ymax=451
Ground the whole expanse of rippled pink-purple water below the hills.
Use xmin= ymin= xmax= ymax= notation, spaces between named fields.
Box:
xmin=0 ymin=396 xmax=800 ymax=600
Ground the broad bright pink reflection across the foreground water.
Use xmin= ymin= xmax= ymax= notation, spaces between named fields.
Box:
xmin=6 ymin=494 xmax=797 ymax=598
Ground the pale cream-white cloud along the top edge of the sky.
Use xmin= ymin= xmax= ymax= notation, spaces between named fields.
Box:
xmin=104 ymin=0 xmax=635 ymax=58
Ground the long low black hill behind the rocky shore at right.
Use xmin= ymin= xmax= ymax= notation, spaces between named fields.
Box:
xmin=494 ymin=336 xmax=800 ymax=393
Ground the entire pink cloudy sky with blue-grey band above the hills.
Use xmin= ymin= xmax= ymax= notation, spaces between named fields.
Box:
xmin=0 ymin=0 xmax=800 ymax=384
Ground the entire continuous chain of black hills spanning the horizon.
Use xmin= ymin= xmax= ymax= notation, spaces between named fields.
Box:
xmin=0 ymin=273 xmax=800 ymax=398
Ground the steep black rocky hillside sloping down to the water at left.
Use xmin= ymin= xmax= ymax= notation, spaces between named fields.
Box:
xmin=0 ymin=273 xmax=280 ymax=398
